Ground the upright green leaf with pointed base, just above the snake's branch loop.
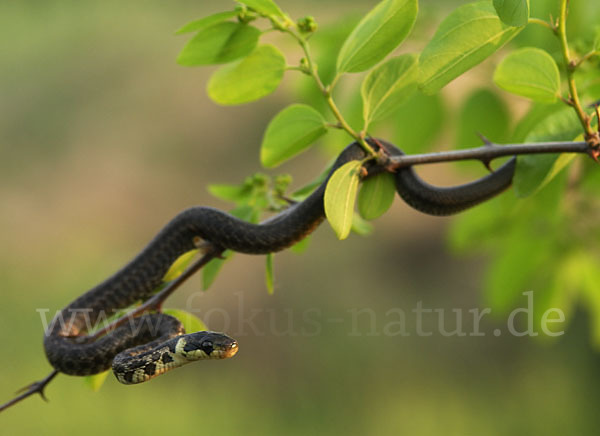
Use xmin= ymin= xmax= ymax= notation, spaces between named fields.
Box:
xmin=361 ymin=54 xmax=419 ymax=130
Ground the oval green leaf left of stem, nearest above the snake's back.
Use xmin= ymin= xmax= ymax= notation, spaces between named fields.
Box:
xmin=260 ymin=104 xmax=327 ymax=167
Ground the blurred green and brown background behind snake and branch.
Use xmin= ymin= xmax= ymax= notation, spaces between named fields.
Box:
xmin=0 ymin=0 xmax=600 ymax=436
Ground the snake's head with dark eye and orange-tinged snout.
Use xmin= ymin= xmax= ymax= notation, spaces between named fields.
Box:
xmin=176 ymin=332 xmax=238 ymax=360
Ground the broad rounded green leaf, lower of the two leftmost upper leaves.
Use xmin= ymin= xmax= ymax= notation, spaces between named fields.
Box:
xmin=208 ymin=45 xmax=285 ymax=105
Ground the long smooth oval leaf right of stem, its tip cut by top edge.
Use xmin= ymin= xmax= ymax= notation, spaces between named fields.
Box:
xmin=337 ymin=0 xmax=418 ymax=73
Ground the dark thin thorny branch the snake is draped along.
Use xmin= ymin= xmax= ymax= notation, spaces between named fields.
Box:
xmin=0 ymin=138 xmax=600 ymax=412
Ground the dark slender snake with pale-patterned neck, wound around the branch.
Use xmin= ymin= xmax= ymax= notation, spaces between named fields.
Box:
xmin=44 ymin=138 xmax=516 ymax=384
